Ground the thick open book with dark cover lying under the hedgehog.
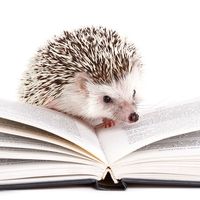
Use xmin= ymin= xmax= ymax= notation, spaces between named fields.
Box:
xmin=0 ymin=100 xmax=200 ymax=189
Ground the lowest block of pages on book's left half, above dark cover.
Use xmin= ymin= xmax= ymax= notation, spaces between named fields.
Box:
xmin=0 ymin=159 xmax=103 ymax=185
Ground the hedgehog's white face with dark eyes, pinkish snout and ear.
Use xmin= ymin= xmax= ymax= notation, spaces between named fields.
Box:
xmin=77 ymin=70 xmax=141 ymax=123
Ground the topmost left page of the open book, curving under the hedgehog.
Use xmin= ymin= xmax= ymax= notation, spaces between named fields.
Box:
xmin=0 ymin=100 xmax=106 ymax=162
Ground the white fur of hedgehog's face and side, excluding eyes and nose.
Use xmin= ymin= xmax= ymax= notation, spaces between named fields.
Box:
xmin=49 ymin=68 xmax=140 ymax=122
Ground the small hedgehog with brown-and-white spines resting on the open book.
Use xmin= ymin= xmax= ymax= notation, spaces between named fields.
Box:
xmin=19 ymin=27 xmax=142 ymax=128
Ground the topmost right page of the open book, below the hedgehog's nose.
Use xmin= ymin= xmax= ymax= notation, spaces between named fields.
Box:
xmin=98 ymin=97 xmax=200 ymax=164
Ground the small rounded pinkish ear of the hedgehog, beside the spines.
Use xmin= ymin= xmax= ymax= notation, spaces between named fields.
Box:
xmin=75 ymin=72 xmax=90 ymax=93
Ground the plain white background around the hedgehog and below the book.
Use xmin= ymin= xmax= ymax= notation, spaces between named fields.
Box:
xmin=0 ymin=0 xmax=200 ymax=200
